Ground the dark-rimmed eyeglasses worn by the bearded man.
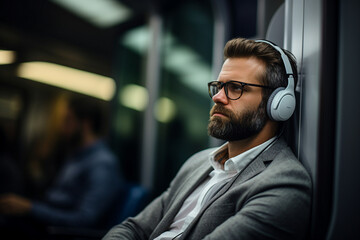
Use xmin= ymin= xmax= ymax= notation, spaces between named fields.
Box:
xmin=208 ymin=81 xmax=274 ymax=100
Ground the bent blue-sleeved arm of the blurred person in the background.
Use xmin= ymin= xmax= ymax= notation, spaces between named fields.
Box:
xmin=30 ymin=158 xmax=120 ymax=227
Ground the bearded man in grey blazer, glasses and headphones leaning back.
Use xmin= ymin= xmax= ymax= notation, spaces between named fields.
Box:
xmin=104 ymin=38 xmax=311 ymax=240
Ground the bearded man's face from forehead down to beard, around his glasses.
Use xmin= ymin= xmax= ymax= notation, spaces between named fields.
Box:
xmin=208 ymin=58 xmax=267 ymax=141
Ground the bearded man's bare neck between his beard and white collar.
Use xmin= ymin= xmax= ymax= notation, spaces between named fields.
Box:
xmin=228 ymin=121 xmax=277 ymax=158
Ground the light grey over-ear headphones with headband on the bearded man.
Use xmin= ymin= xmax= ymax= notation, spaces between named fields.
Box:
xmin=255 ymin=40 xmax=296 ymax=121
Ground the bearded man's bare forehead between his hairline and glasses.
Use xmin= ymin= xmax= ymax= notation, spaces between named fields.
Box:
xmin=218 ymin=57 xmax=265 ymax=84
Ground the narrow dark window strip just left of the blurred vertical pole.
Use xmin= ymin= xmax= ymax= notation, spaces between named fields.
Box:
xmin=111 ymin=23 xmax=150 ymax=181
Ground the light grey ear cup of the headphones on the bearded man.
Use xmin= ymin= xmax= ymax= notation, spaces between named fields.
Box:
xmin=267 ymin=88 xmax=296 ymax=121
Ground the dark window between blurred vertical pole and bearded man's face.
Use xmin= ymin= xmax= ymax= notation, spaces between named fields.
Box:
xmin=155 ymin=1 xmax=214 ymax=195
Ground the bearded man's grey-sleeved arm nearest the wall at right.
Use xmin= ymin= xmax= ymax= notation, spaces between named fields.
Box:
xmin=204 ymin=185 xmax=310 ymax=240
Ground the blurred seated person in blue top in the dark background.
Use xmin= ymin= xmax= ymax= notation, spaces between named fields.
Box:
xmin=0 ymin=97 xmax=123 ymax=238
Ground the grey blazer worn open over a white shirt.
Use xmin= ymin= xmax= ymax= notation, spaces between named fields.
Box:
xmin=103 ymin=140 xmax=311 ymax=240
